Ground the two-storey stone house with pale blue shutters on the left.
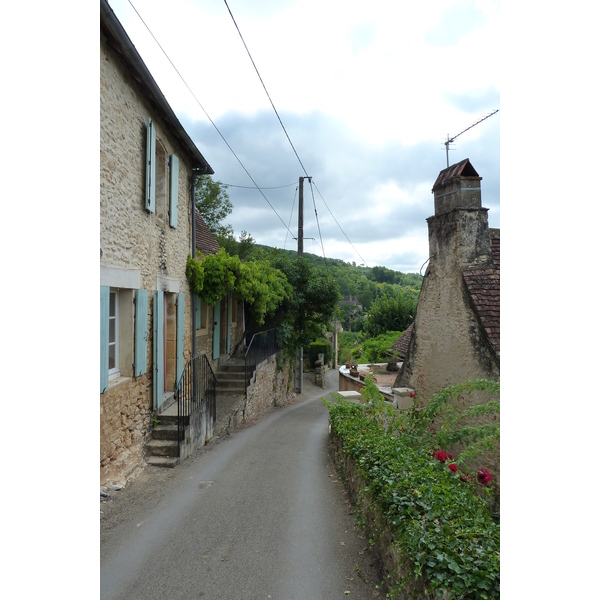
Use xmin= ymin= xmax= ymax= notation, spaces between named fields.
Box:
xmin=100 ymin=0 xmax=213 ymax=483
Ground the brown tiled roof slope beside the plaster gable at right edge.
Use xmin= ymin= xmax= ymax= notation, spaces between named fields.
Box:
xmin=462 ymin=229 xmax=500 ymax=360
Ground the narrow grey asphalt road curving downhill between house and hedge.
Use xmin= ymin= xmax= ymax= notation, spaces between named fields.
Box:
xmin=100 ymin=371 xmax=381 ymax=600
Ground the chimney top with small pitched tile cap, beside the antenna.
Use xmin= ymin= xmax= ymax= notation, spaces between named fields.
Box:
xmin=431 ymin=158 xmax=481 ymax=216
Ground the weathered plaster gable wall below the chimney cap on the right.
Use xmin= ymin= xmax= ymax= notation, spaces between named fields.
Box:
xmin=394 ymin=209 xmax=500 ymax=397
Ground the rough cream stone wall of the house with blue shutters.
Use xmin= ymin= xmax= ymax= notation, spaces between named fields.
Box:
xmin=100 ymin=39 xmax=192 ymax=484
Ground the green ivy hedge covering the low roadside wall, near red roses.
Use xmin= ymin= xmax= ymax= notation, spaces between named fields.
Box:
xmin=325 ymin=378 xmax=500 ymax=599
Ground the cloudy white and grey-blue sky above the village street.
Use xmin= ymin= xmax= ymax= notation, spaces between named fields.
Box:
xmin=109 ymin=0 xmax=502 ymax=272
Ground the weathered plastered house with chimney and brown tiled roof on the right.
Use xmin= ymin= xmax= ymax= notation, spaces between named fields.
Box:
xmin=395 ymin=158 xmax=500 ymax=397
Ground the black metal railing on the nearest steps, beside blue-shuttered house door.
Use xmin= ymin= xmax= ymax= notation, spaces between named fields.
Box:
xmin=175 ymin=354 xmax=217 ymax=444
